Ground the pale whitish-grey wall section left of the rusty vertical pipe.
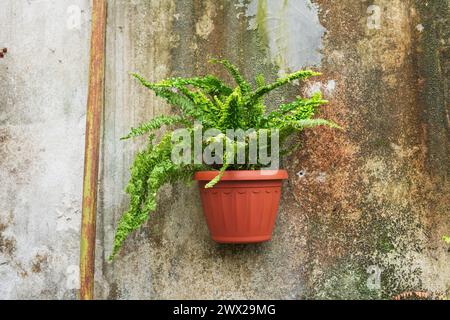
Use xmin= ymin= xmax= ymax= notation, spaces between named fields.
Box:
xmin=0 ymin=0 xmax=90 ymax=299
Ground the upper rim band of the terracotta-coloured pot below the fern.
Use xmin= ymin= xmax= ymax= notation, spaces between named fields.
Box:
xmin=194 ymin=170 xmax=288 ymax=181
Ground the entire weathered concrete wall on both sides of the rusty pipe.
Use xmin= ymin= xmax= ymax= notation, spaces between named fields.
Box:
xmin=0 ymin=0 xmax=450 ymax=299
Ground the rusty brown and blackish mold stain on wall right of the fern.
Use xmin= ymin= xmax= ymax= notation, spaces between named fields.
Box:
xmin=294 ymin=0 xmax=450 ymax=299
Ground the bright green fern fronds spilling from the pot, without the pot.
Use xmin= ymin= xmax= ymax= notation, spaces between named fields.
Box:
xmin=110 ymin=60 xmax=340 ymax=259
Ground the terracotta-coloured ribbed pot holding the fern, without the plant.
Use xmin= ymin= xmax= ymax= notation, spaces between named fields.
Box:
xmin=194 ymin=170 xmax=288 ymax=243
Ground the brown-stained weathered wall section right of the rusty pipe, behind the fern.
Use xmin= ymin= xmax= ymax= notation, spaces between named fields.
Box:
xmin=98 ymin=0 xmax=450 ymax=299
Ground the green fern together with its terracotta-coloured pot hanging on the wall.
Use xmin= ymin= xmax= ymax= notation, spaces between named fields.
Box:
xmin=110 ymin=60 xmax=338 ymax=259
